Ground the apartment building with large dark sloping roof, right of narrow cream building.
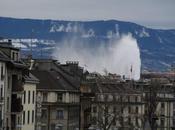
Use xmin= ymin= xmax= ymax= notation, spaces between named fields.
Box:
xmin=27 ymin=59 xmax=82 ymax=130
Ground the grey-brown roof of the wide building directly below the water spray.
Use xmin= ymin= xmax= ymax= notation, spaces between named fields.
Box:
xmin=83 ymin=75 xmax=140 ymax=94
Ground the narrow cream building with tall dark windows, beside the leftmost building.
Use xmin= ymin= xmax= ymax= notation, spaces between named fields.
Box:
xmin=22 ymin=74 xmax=39 ymax=130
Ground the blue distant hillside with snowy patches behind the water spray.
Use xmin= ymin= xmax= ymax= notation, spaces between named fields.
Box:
xmin=0 ymin=17 xmax=175 ymax=71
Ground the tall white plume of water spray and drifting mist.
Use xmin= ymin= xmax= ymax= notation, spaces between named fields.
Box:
xmin=53 ymin=34 xmax=141 ymax=80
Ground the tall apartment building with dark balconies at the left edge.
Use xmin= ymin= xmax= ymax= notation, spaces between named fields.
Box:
xmin=0 ymin=40 xmax=26 ymax=130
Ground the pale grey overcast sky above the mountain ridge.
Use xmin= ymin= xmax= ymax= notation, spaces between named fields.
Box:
xmin=0 ymin=0 xmax=175 ymax=29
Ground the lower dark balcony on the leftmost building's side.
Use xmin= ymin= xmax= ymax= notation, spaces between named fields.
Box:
xmin=11 ymin=95 xmax=23 ymax=113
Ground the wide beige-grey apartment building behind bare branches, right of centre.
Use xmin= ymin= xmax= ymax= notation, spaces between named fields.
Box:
xmin=80 ymin=74 xmax=144 ymax=130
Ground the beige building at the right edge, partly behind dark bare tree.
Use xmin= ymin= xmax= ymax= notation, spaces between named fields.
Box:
xmin=135 ymin=74 xmax=175 ymax=130
